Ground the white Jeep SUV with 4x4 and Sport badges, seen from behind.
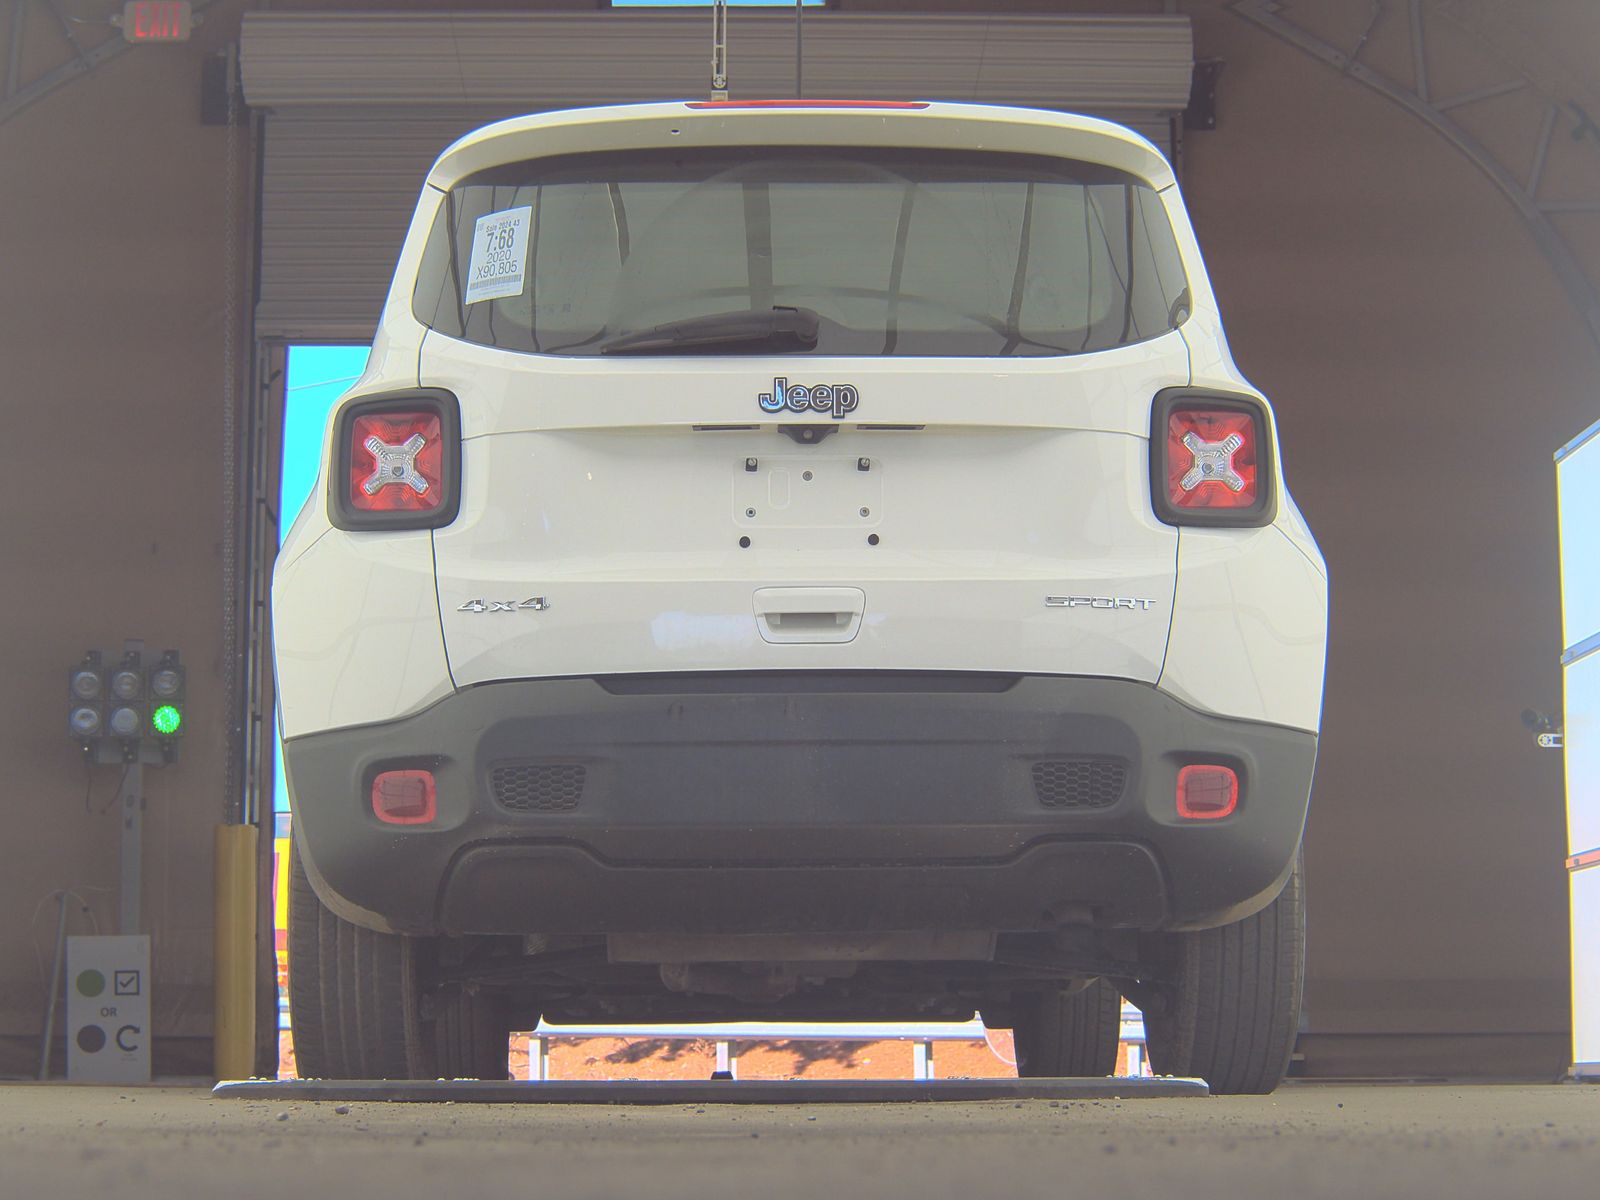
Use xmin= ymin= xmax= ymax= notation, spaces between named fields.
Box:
xmin=274 ymin=101 xmax=1326 ymax=1091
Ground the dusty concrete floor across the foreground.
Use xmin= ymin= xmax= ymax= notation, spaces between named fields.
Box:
xmin=0 ymin=1083 xmax=1600 ymax=1200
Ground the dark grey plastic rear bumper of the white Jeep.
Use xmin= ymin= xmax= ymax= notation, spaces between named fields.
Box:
xmin=285 ymin=672 xmax=1317 ymax=934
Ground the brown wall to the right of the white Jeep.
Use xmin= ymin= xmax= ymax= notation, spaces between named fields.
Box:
xmin=1186 ymin=3 xmax=1600 ymax=1074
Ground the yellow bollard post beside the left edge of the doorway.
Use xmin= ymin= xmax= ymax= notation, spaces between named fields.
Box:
xmin=213 ymin=826 xmax=256 ymax=1080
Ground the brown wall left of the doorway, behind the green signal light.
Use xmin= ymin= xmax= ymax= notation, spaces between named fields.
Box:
xmin=0 ymin=6 xmax=250 ymax=1074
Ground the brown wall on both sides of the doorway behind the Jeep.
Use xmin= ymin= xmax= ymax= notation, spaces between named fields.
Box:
xmin=0 ymin=0 xmax=1600 ymax=1074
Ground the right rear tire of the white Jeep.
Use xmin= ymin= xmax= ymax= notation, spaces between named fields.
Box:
xmin=1144 ymin=861 xmax=1306 ymax=1096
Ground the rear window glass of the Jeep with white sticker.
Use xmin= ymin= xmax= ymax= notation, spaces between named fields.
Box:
xmin=413 ymin=147 xmax=1189 ymax=355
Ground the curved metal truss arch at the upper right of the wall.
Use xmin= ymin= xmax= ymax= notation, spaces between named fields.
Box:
xmin=1229 ymin=0 xmax=1600 ymax=355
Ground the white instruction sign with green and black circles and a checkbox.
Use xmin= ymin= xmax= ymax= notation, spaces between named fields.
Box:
xmin=67 ymin=934 xmax=150 ymax=1083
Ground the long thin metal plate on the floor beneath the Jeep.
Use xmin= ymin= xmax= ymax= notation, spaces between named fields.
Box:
xmin=211 ymin=1077 xmax=1211 ymax=1104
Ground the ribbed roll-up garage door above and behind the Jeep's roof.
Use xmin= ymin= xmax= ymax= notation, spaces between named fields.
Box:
xmin=240 ymin=10 xmax=1194 ymax=341
